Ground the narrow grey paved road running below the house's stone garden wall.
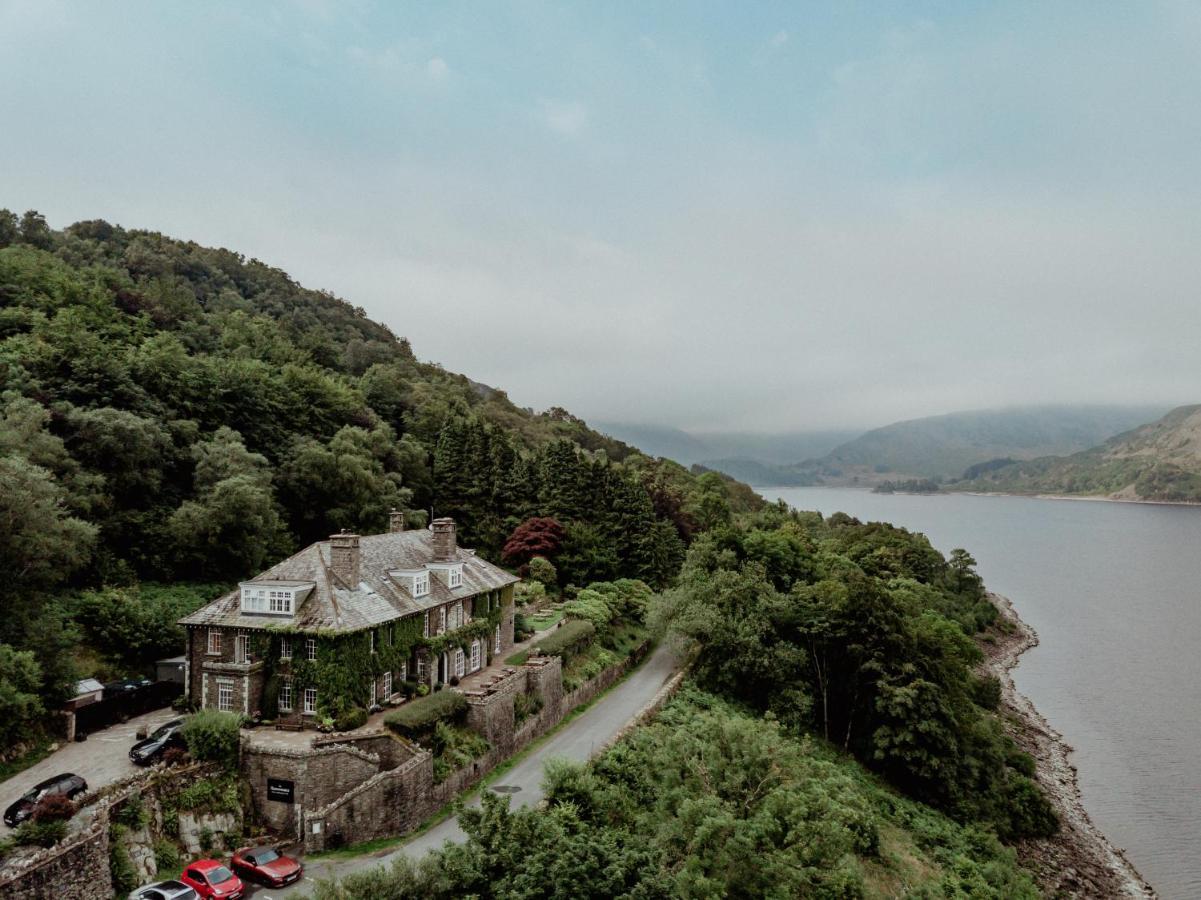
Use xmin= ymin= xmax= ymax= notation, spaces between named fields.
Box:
xmin=276 ymin=644 xmax=677 ymax=900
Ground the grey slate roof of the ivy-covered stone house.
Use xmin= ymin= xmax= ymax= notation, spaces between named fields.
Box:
xmin=179 ymin=530 xmax=519 ymax=632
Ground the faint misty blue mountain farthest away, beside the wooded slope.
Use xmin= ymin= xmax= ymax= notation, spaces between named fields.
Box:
xmin=596 ymin=422 xmax=862 ymax=473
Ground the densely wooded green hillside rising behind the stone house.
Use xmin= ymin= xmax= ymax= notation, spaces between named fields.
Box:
xmin=0 ymin=210 xmax=761 ymax=739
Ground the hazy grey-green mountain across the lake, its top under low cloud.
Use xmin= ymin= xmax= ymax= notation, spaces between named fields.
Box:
xmin=789 ymin=406 xmax=1165 ymax=484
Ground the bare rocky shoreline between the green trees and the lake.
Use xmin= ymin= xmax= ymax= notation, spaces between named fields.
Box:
xmin=982 ymin=594 xmax=1157 ymax=899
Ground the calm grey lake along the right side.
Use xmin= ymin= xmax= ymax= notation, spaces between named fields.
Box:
xmin=758 ymin=488 xmax=1201 ymax=900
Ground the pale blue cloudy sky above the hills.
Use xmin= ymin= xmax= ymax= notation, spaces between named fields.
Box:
xmin=0 ymin=0 xmax=1201 ymax=431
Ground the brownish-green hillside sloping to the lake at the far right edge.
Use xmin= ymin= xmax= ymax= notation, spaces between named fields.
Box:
xmin=952 ymin=405 xmax=1201 ymax=502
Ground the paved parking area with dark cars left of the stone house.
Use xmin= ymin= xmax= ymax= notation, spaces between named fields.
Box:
xmin=0 ymin=708 xmax=179 ymax=809
